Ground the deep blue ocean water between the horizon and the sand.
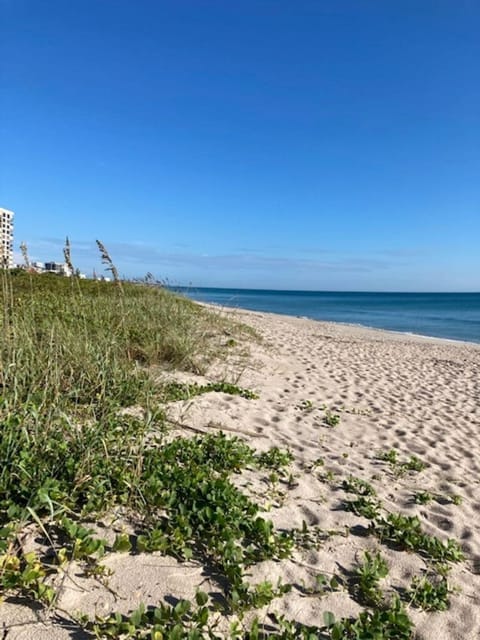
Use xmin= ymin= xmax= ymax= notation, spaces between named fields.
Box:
xmin=175 ymin=287 xmax=480 ymax=343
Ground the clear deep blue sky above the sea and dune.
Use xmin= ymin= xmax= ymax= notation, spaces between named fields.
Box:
xmin=0 ymin=0 xmax=480 ymax=291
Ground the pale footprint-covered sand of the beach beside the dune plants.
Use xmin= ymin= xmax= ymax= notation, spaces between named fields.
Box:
xmin=0 ymin=309 xmax=480 ymax=640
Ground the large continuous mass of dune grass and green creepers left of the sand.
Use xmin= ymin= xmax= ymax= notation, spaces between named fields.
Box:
xmin=0 ymin=266 xmax=284 ymax=600
